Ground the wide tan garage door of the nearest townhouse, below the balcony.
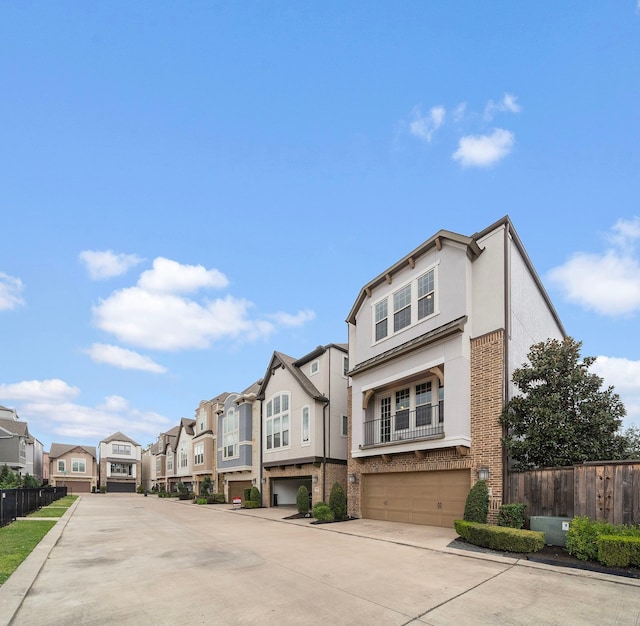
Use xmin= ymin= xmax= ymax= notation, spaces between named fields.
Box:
xmin=362 ymin=470 xmax=471 ymax=528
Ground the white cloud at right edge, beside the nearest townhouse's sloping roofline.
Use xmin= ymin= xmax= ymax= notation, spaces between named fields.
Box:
xmin=547 ymin=218 xmax=640 ymax=316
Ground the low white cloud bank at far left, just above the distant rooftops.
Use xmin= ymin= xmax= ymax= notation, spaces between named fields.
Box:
xmin=0 ymin=379 xmax=170 ymax=446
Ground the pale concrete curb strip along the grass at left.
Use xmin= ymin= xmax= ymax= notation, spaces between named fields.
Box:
xmin=0 ymin=496 xmax=82 ymax=626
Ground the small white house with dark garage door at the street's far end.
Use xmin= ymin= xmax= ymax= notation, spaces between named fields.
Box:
xmin=99 ymin=432 xmax=142 ymax=493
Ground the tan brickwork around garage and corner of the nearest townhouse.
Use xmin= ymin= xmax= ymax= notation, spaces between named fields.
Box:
xmin=347 ymin=330 xmax=504 ymax=522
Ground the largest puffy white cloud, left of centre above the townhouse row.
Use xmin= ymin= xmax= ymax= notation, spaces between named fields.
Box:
xmin=93 ymin=258 xmax=313 ymax=351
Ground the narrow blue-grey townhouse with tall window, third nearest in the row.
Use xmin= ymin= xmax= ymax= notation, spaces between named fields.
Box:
xmin=217 ymin=380 xmax=262 ymax=502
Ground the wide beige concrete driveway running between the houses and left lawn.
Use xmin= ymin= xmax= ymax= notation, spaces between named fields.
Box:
xmin=0 ymin=494 xmax=640 ymax=626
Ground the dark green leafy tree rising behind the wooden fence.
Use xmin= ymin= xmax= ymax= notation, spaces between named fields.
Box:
xmin=500 ymin=337 xmax=628 ymax=472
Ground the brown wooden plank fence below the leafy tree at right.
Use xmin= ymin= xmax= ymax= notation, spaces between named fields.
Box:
xmin=508 ymin=461 xmax=640 ymax=524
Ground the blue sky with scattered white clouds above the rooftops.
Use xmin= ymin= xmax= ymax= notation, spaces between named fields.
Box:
xmin=0 ymin=0 xmax=640 ymax=449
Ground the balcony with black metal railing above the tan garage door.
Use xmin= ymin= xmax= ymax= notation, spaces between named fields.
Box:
xmin=364 ymin=402 xmax=444 ymax=447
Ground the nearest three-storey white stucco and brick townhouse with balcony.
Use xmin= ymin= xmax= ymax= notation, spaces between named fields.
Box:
xmin=347 ymin=217 xmax=565 ymax=527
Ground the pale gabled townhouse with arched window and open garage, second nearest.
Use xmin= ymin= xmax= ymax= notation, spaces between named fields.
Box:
xmin=257 ymin=344 xmax=348 ymax=506
